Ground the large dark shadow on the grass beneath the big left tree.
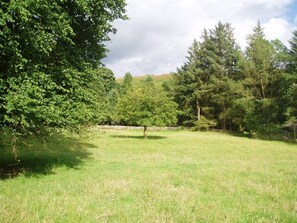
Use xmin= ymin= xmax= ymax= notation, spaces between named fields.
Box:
xmin=0 ymin=134 xmax=95 ymax=180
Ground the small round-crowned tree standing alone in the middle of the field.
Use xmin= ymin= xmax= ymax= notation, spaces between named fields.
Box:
xmin=117 ymin=80 xmax=177 ymax=138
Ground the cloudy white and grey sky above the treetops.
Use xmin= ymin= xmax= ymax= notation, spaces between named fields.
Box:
xmin=103 ymin=0 xmax=297 ymax=77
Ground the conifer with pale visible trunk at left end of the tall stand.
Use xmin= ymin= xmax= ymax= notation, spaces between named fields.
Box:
xmin=173 ymin=34 xmax=210 ymax=125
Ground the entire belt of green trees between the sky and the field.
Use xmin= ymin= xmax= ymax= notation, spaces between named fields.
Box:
xmin=0 ymin=0 xmax=297 ymax=142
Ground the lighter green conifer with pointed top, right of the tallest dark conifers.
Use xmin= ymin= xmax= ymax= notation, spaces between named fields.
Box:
xmin=238 ymin=22 xmax=286 ymax=131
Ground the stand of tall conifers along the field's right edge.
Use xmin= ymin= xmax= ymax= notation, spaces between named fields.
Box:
xmin=172 ymin=22 xmax=297 ymax=137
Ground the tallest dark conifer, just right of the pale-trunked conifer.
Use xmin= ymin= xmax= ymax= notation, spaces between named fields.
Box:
xmin=208 ymin=22 xmax=242 ymax=130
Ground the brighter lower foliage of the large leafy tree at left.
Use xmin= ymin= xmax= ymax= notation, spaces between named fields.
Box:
xmin=2 ymin=69 xmax=115 ymax=133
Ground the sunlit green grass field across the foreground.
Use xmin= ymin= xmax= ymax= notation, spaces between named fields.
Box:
xmin=0 ymin=130 xmax=297 ymax=223
